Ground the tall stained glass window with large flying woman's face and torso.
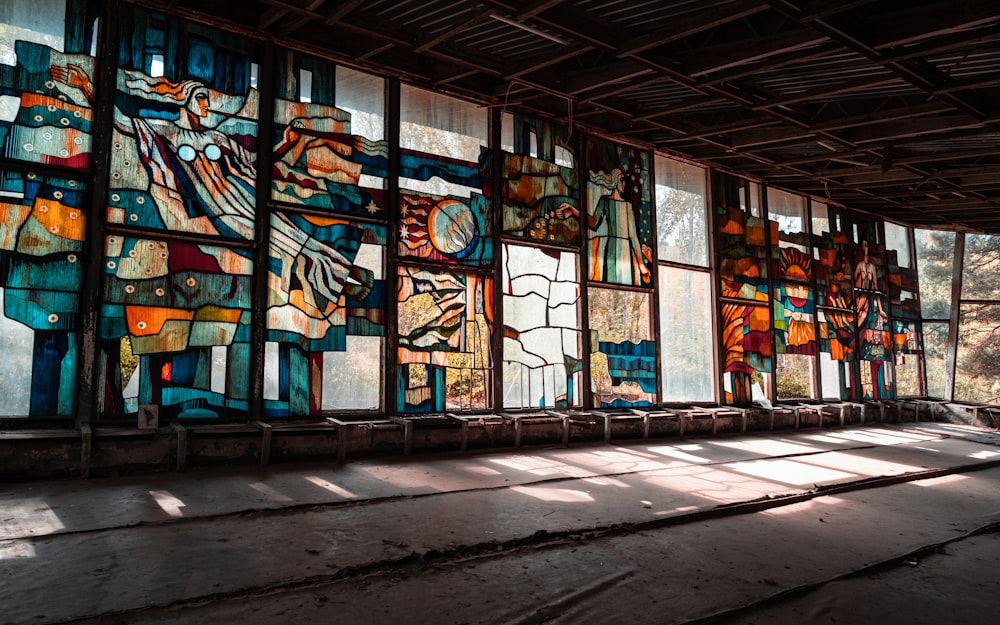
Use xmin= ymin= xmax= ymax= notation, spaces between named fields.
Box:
xmin=98 ymin=7 xmax=260 ymax=419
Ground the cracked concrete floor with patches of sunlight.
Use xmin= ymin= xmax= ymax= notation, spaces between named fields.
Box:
xmin=0 ymin=423 xmax=1000 ymax=625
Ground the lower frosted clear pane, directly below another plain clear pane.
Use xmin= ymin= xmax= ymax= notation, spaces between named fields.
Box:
xmin=660 ymin=266 xmax=716 ymax=402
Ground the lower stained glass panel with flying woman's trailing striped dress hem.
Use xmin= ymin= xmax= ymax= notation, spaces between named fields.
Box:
xmin=264 ymin=212 xmax=385 ymax=416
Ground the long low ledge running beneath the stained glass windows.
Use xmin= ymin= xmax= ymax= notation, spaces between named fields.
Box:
xmin=0 ymin=398 xmax=984 ymax=480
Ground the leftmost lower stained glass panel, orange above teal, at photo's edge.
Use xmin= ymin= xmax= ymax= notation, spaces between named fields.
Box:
xmin=0 ymin=169 xmax=87 ymax=416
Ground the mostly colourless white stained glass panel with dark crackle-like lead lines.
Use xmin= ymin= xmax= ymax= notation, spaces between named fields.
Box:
xmin=503 ymin=245 xmax=583 ymax=408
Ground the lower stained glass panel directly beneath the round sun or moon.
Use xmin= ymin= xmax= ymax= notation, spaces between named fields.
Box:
xmin=397 ymin=267 xmax=493 ymax=412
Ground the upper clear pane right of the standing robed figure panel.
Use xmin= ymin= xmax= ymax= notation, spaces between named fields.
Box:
xmin=655 ymin=156 xmax=708 ymax=267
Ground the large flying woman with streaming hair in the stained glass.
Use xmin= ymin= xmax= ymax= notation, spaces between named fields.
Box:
xmin=52 ymin=66 xmax=371 ymax=326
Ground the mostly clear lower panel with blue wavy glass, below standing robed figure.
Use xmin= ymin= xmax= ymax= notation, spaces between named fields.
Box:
xmin=588 ymin=288 xmax=657 ymax=408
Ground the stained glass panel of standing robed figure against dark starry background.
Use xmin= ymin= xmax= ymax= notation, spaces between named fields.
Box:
xmin=586 ymin=139 xmax=655 ymax=287
